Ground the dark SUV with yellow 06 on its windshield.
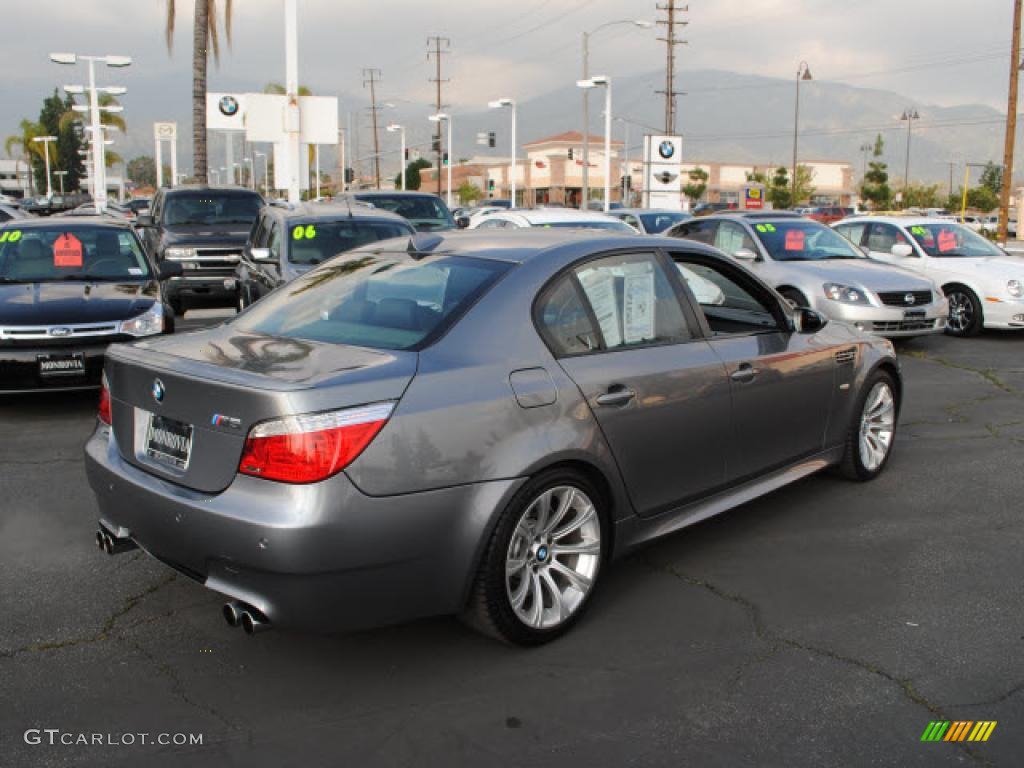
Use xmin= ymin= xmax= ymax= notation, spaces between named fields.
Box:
xmin=239 ymin=201 xmax=416 ymax=311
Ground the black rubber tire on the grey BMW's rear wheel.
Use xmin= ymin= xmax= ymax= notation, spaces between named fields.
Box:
xmin=462 ymin=468 xmax=610 ymax=646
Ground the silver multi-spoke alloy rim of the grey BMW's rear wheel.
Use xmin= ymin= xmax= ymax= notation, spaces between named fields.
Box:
xmin=505 ymin=485 xmax=601 ymax=629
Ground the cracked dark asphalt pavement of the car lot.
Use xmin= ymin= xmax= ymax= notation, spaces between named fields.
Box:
xmin=0 ymin=311 xmax=1024 ymax=766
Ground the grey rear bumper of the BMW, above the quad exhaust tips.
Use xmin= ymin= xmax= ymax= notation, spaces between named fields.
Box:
xmin=85 ymin=425 xmax=522 ymax=631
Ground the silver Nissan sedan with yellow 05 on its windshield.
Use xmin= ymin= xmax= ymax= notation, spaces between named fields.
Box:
xmin=669 ymin=212 xmax=948 ymax=337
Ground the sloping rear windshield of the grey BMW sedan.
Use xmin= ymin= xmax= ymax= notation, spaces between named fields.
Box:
xmin=232 ymin=253 xmax=510 ymax=349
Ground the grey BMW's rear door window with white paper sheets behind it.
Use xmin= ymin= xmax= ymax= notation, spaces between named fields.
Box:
xmin=574 ymin=254 xmax=690 ymax=349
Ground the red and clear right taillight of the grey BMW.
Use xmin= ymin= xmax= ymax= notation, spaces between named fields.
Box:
xmin=239 ymin=402 xmax=394 ymax=482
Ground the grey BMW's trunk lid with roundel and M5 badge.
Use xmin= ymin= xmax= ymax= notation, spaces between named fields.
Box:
xmin=106 ymin=326 xmax=418 ymax=494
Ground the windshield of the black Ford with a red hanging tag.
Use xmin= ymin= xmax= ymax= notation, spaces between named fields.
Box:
xmin=0 ymin=222 xmax=151 ymax=283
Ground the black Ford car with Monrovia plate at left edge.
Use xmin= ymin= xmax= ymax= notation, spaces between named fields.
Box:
xmin=0 ymin=216 xmax=180 ymax=393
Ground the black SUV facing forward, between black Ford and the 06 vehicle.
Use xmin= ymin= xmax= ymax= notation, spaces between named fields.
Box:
xmin=135 ymin=185 xmax=263 ymax=315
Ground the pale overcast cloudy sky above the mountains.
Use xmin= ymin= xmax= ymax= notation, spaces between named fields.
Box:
xmin=6 ymin=0 xmax=1013 ymax=162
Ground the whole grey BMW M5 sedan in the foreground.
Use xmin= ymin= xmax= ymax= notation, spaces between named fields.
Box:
xmin=86 ymin=230 xmax=902 ymax=645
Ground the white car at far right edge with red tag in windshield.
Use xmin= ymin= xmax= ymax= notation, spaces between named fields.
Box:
xmin=836 ymin=216 xmax=1024 ymax=336
